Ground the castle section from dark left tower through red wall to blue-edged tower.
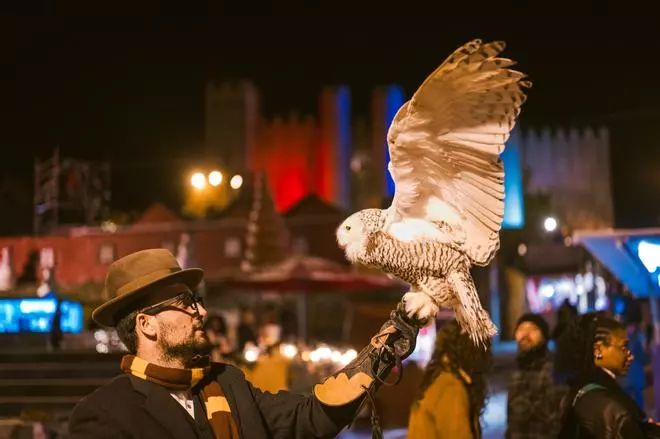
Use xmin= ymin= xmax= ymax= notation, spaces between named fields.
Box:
xmin=205 ymin=82 xmax=352 ymax=212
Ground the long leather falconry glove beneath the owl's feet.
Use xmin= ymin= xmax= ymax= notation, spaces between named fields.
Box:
xmin=314 ymin=302 xmax=419 ymax=406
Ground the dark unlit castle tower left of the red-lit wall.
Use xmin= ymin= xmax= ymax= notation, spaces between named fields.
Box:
xmin=204 ymin=81 xmax=259 ymax=175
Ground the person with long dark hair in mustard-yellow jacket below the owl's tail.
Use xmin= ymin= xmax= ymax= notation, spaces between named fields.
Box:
xmin=408 ymin=320 xmax=492 ymax=439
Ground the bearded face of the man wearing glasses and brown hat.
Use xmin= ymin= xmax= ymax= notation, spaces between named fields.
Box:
xmin=146 ymin=297 xmax=210 ymax=363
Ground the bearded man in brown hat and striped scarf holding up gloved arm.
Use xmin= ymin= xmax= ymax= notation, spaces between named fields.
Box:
xmin=69 ymin=249 xmax=417 ymax=439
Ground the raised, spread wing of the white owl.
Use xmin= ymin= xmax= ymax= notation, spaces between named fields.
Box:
xmin=386 ymin=40 xmax=531 ymax=265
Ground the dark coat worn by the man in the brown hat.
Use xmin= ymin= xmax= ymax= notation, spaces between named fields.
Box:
xmin=69 ymin=365 xmax=358 ymax=439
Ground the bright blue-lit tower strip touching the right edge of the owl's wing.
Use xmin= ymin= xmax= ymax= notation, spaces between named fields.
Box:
xmin=501 ymin=128 xmax=525 ymax=229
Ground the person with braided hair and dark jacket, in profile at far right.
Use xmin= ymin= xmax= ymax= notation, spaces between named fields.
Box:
xmin=554 ymin=313 xmax=660 ymax=439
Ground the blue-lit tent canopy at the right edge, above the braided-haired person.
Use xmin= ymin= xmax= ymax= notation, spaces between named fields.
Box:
xmin=573 ymin=228 xmax=660 ymax=298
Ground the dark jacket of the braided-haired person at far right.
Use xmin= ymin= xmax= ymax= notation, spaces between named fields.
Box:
xmin=559 ymin=370 xmax=658 ymax=439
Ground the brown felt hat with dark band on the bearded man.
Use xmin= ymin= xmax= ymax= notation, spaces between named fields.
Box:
xmin=92 ymin=248 xmax=204 ymax=327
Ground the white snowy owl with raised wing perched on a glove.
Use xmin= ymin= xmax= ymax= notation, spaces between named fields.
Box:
xmin=337 ymin=40 xmax=531 ymax=344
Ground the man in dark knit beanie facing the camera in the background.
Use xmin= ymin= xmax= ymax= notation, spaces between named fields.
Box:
xmin=505 ymin=313 xmax=567 ymax=439
